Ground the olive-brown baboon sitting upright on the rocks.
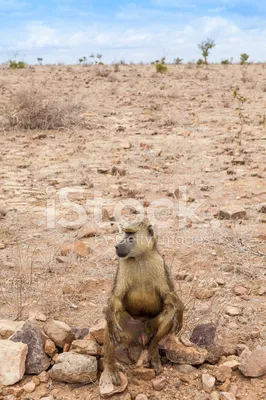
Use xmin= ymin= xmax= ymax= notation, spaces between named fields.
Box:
xmin=104 ymin=222 xmax=184 ymax=385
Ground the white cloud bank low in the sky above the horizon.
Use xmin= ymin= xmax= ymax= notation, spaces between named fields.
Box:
xmin=0 ymin=14 xmax=266 ymax=63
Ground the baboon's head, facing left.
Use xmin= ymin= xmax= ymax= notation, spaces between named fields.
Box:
xmin=115 ymin=225 xmax=156 ymax=258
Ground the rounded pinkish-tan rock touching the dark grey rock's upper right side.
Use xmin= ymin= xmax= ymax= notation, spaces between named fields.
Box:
xmin=44 ymin=320 xmax=75 ymax=348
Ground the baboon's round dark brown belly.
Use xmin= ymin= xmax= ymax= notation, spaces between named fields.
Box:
xmin=123 ymin=284 xmax=162 ymax=318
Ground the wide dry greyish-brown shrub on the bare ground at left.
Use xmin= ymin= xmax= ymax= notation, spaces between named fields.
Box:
xmin=0 ymin=88 xmax=85 ymax=131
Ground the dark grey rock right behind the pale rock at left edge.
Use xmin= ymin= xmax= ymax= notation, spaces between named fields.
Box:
xmin=10 ymin=319 xmax=50 ymax=375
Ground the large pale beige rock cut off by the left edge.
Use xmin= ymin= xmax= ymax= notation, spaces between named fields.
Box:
xmin=0 ymin=340 xmax=28 ymax=385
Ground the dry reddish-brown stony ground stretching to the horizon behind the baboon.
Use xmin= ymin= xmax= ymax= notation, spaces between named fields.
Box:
xmin=0 ymin=65 xmax=266 ymax=400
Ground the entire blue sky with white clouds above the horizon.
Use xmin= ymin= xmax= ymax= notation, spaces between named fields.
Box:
xmin=0 ymin=0 xmax=266 ymax=64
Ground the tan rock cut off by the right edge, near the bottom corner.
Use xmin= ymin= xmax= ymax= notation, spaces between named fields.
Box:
xmin=239 ymin=346 xmax=266 ymax=378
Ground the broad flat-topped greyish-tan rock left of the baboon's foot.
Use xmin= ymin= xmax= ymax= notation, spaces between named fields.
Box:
xmin=50 ymin=353 xmax=97 ymax=383
